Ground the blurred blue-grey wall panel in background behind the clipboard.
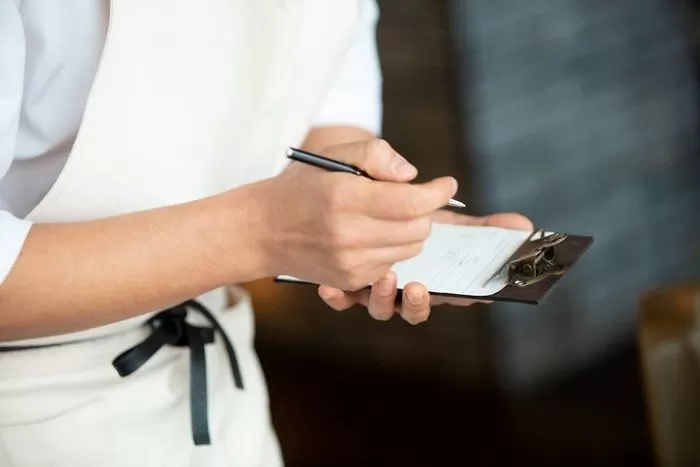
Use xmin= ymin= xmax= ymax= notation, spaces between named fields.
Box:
xmin=451 ymin=0 xmax=700 ymax=387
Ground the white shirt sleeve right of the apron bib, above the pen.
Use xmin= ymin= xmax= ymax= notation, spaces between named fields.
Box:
xmin=312 ymin=0 xmax=383 ymax=136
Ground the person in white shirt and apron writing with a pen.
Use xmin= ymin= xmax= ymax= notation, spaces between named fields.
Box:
xmin=0 ymin=0 xmax=529 ymax=467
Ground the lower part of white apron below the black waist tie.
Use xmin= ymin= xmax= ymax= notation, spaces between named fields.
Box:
xmin=0 ymin=296 xmax=283 ymax=467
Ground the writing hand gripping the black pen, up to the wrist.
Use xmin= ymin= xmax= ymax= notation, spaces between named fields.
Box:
xmin=249 ymin=139 xmax=457 ymax=291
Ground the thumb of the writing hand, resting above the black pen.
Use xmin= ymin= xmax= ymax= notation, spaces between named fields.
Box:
xmin=326 ymin=139 xmax=418 ymax=182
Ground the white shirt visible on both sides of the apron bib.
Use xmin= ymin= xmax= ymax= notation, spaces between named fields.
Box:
xmin=0 ymin=0 xmax=382 ymax=284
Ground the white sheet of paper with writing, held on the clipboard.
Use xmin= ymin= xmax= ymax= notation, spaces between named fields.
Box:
xmin=279 ymin=224 xmax=532 ymax=297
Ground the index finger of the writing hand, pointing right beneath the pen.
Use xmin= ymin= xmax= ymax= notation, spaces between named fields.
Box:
xmin=362 ymin=177 xmax=457 ymax=220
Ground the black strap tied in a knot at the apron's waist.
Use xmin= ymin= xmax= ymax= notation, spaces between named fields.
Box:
xmin=112 ymin=300 xmax=243 ymax=445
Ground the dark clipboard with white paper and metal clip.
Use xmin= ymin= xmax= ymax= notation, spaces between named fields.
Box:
xmin=276 ymin=224 xmax=593 ymax=303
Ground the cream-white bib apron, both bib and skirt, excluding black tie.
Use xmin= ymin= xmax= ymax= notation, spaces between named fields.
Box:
xmin=0 ymin=0 xmax=360 ymax=467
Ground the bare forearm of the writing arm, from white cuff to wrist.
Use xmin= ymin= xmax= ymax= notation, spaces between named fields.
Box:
xmin=0 ymin=187 xmax=265 ymax=341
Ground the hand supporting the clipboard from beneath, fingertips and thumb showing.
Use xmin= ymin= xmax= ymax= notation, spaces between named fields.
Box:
xmin=318 ymin=210 xmax=533 ymax=324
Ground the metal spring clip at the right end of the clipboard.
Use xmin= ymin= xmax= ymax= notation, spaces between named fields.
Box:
xmin=497 ymin=229 xmax=569 ymax=287
